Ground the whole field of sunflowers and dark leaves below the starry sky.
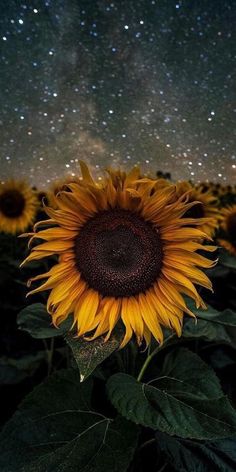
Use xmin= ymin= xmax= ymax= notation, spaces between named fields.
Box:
xmin=0 ymin=162 xmax=236 ymax=472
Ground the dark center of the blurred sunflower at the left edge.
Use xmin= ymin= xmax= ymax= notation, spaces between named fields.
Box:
xmin=0 ymin=190 xmax=25 ymax=218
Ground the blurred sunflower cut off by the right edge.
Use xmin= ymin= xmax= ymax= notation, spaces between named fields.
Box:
xmin=219 ymin=205 xmax=236 ymax=256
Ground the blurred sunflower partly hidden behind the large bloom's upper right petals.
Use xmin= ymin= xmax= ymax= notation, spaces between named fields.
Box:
xmin=176 ymin=181 xmax=221 ymax=237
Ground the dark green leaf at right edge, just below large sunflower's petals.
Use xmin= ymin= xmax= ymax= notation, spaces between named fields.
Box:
xmin=182 ymin=300 xmax=236 ymax=347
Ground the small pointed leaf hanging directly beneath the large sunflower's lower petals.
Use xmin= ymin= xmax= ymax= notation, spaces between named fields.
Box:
xmin=65 ymin=326 xmax=124 ymax=382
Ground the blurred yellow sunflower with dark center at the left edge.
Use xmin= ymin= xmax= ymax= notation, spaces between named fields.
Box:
xmin=0 ymin=179 xmax=38 ymax=234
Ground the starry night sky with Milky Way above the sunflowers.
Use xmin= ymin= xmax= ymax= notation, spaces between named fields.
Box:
xmin=0 ymin=0 xmax=236 ymax=188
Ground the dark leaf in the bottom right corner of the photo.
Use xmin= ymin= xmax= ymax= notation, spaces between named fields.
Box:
xmin=156 ymin=432 xmax=236 ymax=472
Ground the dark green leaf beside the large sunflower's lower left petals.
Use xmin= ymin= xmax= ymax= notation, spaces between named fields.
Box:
xmin=17 ymin=303 xmax=72 ymax=339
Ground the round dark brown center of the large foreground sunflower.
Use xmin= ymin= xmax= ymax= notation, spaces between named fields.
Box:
xmin=75 ymin=209 xmax=162 ymax=297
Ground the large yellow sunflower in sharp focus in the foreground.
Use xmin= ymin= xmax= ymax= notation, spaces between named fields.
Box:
xmin=21 ymin=163 xmax=215 ymax=347
